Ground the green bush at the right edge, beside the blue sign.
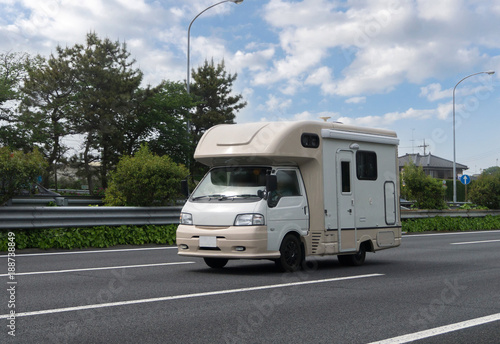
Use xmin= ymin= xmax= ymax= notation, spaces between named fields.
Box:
xmin=469 ymin=166 xmax=500 ymax=209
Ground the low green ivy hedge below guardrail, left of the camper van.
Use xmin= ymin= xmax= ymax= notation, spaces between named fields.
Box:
xmin=0 ymin=225 xmax=177 ymax=251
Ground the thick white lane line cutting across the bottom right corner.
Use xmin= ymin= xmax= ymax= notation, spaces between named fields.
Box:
xmin=370 ymin=313 xmax=500 ymax=344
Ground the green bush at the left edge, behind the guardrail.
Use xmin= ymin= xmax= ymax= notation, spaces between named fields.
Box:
xmin=0 ymin=147 xmax=46 ymax=205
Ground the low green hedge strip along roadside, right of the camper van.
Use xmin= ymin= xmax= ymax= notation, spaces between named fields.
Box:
xmin=402 ymin=215 xmax=500 ymax=233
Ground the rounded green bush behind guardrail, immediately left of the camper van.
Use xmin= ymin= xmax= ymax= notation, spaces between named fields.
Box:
xmin=104 ymin=145 xmax=188 ymax=206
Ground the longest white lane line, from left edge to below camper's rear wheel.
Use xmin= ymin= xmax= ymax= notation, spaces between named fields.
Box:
xmin=0 ymin=274 xmax=384 ymax=319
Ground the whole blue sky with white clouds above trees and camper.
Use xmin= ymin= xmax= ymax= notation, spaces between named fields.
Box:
xmin=0 ymin=0 xmax=500 ymax=174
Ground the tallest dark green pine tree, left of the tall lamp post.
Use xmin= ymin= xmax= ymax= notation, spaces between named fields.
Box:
xmin=64 ymin=33 xmax=142 ymax=189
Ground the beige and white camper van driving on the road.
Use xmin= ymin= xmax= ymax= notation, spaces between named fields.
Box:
xmin=177 ymin=121 xmax=401 ymax=271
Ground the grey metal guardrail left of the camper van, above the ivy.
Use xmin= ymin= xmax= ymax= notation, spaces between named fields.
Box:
xmin=0 ymin=207 xmax=182 ymax=229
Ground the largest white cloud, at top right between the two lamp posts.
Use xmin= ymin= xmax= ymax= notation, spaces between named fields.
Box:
xmin=254 ymin=0 xmax=500 ymax=97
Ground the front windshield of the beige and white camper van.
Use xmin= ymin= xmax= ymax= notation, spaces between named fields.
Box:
xmin=191 ymin=166 xmax=271 ymax=201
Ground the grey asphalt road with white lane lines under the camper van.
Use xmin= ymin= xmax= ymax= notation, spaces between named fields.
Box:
xmin=0 ymin=231 xmax=500 ymax=343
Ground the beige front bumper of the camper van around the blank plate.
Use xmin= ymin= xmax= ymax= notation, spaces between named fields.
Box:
xmin=176 ymin=225 xmax=280 ymax=259
